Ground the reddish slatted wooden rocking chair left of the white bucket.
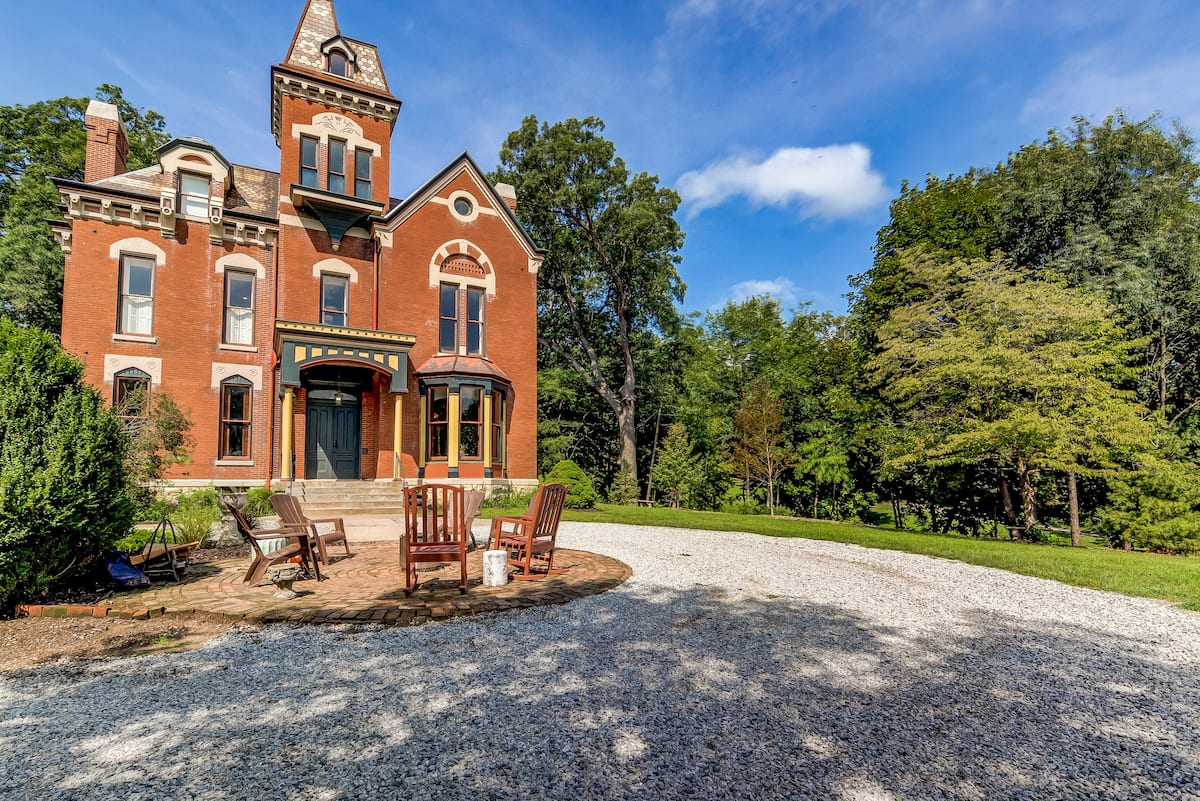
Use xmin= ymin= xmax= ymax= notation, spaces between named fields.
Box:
xmin=400 ymin=484 xmax=468 ymax=595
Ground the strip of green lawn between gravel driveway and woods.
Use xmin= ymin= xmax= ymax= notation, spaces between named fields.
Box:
xmin=482 ymin=504 xmax=1200 ymax=610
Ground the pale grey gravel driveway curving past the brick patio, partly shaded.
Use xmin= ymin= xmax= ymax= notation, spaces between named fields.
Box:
xmin=0 ymin=523 xmax=1200 ymax=801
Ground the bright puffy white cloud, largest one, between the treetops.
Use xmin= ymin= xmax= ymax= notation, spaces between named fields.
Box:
xmin=677 ymin=143 xmax=887 ymax=218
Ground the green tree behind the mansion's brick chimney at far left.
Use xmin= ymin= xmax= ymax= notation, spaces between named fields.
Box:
xmin=0 ymin=84 xmax=169 ymax=331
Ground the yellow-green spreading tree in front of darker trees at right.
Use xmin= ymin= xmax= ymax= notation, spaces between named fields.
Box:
xmin=869 ymin=251 xmax=1154 ymax=537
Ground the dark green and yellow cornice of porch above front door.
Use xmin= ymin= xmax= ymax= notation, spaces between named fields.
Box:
xmin=275 ymin=320 xmax=416 ymax=392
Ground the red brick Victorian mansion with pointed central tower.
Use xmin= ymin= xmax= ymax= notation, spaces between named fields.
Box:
xmin=55 ymin=0 xmax=542 ymax=487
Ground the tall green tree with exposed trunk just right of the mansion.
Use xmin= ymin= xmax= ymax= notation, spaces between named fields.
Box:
xmin=493 ymin=116 xmax=684 ymax=484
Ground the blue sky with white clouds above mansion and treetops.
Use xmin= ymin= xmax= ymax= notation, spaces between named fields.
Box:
xmin=0 ymin=0 xmax=1200 ymax=312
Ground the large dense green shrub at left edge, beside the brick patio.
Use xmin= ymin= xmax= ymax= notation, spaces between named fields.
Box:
xmin=0 ymin=319 xmax=133 ymax=607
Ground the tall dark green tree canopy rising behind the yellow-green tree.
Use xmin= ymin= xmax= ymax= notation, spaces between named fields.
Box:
xmin=852 ymin=113 xmax=1200 ymax=439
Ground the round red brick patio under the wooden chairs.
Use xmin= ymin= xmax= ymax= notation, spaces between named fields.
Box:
xmin=18 ymin=543 xmax=632 ymax=626
